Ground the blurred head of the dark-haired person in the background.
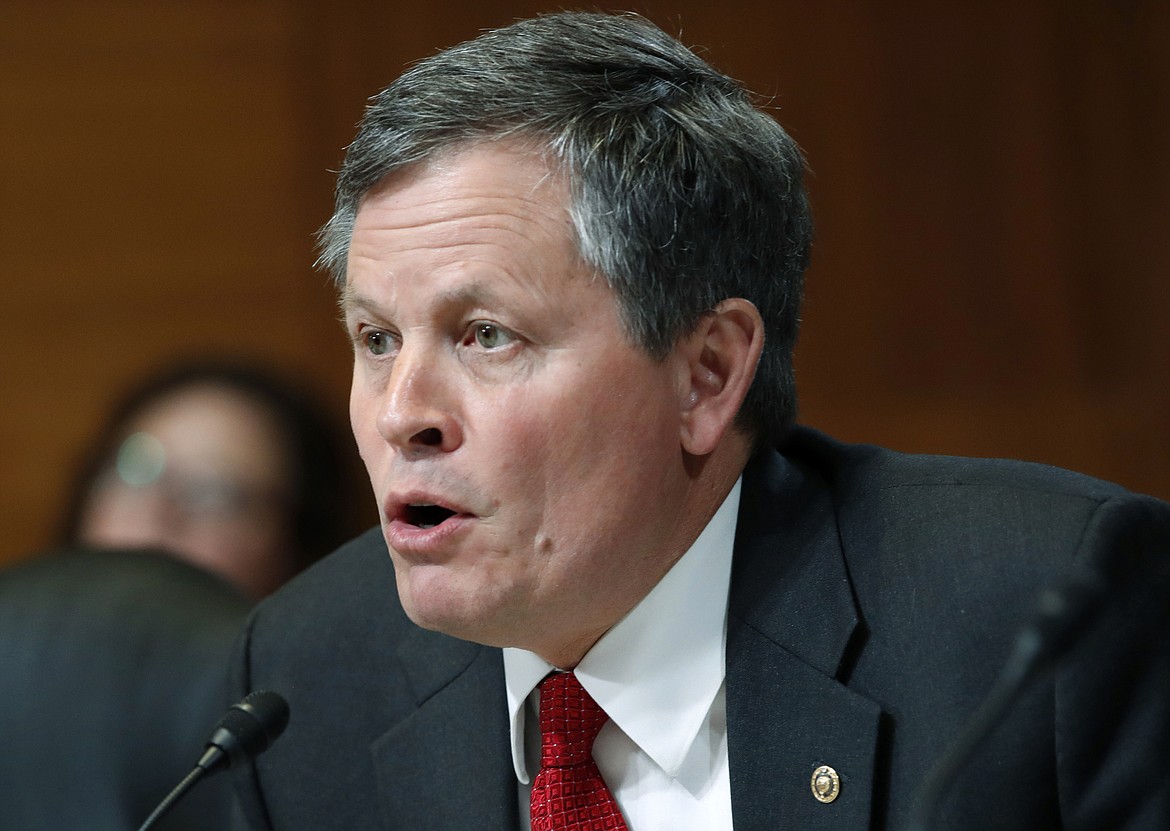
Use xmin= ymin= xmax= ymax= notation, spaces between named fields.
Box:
xmin=62 ymin=360 xmax=365 ymax=598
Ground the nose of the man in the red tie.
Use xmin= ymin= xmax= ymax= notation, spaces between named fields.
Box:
xmin=377 ymin=348 xmax=462 ymax=456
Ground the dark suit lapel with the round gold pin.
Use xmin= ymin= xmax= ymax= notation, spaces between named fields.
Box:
xmin=727 ymin=454 xmax=881 ymax=831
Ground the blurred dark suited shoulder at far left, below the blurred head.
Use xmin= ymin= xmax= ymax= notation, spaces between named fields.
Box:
xmin=0 ymin=549 xmax=252 ymax=831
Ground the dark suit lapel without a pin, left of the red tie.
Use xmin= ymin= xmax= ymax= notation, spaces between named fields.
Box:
xmin=370 ymin=630 xmax=519 ymax=831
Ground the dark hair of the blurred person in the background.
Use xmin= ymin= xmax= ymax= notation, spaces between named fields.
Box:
xmin=60 ymin=358 xmax=374 ymax=595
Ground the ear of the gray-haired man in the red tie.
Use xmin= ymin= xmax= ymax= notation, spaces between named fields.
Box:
xmin=680 ymin=297 xmax=764 ymax=455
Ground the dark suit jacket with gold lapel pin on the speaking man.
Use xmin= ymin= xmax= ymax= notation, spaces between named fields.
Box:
xmin=234 ymin=430 xmax=1170 ymax=831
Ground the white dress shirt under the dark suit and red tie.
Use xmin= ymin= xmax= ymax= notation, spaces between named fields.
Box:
xmin=504 ymin=482 xmax=741 ymax=831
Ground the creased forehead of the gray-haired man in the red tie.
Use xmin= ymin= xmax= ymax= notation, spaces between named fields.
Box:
xmin=342 ymin=142 xmax=608 ymax=316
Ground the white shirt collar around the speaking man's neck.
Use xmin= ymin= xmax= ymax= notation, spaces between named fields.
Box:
xmin=503 ymin=480 xmax=742 ymax=783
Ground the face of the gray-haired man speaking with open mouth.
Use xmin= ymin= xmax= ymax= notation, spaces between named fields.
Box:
xmin=343 ymin=144 xmax=706 ymax=662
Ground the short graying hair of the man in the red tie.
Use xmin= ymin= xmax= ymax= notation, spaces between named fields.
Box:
xmin=318 ymin=13 xmax=812 ymax=446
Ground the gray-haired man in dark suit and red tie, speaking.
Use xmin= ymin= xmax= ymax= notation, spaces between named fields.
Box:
xmin=233 ymin=14 xmax=1170 ymax=831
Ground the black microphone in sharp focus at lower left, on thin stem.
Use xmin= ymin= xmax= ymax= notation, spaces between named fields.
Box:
xmin=138 ymin=689 xmax=289 ymax=831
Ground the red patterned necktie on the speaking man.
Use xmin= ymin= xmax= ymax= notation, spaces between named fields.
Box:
xmin=532 ymin=672 xmax=627 ymax=831
